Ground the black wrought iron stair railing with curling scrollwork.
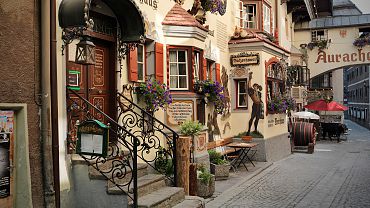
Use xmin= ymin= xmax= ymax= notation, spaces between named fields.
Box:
xmin=67 ymin=89 xmax=178 ymax=207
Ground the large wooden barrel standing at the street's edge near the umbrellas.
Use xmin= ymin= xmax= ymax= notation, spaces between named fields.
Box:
xmin=292 ymin=122 xmax=315 ymax=146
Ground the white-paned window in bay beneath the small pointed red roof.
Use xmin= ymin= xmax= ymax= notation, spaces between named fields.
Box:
xmin=169 ymin=49 xmax=189 ymax=90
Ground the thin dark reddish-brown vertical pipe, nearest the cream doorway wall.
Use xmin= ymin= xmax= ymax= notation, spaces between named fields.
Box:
xmin=50 ymin=0 xmax=60 ymax=208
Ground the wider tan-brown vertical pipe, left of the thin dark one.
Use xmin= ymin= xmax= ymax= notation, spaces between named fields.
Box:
xmin=39 ymin=1 xmax=55 ymax=208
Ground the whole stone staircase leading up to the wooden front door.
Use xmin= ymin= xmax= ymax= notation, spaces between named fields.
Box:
xmin=72 ymin=155 xmax=205 ymax=208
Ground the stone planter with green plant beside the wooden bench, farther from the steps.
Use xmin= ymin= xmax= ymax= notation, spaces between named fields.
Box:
xmin=208 ymin=150 xmax=230 ymax=181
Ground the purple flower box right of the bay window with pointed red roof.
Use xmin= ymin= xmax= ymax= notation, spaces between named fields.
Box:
xmin=194 ymin=80 xmax=226 ymax=114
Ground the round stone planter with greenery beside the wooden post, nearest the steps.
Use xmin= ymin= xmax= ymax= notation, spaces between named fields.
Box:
xmin=197 ymin=166 xmax=215 ymax=198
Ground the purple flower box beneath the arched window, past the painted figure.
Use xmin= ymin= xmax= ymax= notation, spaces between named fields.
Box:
xmin=267 ymin=96 xmax=296 ymax=114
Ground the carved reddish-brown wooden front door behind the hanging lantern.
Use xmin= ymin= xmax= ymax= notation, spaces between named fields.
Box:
xmin=67 ymin=40 xmax=116 ymax=150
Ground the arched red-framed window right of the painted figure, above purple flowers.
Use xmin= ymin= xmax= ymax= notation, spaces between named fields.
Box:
xmin=267 ymin=62 xmax=285 ymax=100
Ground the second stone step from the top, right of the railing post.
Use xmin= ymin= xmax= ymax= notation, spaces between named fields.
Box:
xmin=108 ymin=174 xmax=166 ymax=196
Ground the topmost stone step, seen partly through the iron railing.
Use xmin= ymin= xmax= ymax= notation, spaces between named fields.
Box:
xmin=89 ymin=160 xmax=148 ymax=180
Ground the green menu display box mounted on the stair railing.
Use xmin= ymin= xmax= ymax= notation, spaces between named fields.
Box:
xmin=76 ymin=120 xmax=109 ymax=157
